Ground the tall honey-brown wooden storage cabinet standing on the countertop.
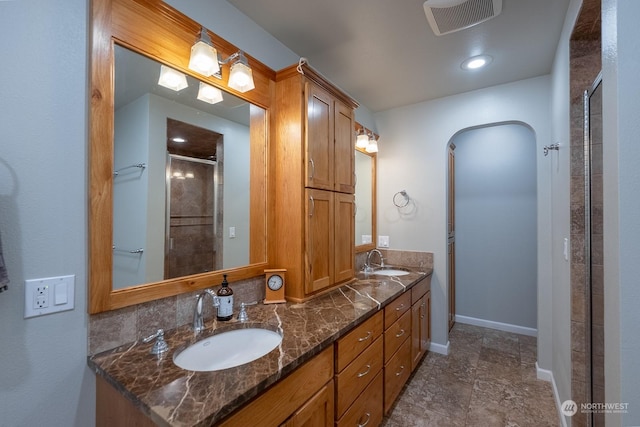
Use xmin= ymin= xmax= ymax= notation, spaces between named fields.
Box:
xmin=270 ymin=65 xmax=357 ymax=302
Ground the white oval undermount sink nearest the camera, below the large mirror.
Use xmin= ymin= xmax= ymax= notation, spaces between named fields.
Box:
xmin=173 ymin=328 xmax=282 ymax=371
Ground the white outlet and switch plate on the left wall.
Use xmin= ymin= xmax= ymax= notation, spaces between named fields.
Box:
xmin=24 ymin=275 xmax=76 ymax=319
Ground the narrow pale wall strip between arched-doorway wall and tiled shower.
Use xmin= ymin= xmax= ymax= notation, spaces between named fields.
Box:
xmin=549 ymin=0 xmax=582 ymax=418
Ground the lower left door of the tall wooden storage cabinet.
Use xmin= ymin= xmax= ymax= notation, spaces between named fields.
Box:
xmin=305 ymin=189 xmax=334 ymax=294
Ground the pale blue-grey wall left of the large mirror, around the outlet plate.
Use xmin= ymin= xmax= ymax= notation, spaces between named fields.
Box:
xmin=0 ymin=0 xmax=95 ymax=427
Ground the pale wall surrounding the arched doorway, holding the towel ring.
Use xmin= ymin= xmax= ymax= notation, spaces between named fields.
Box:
xmin=376 ymin=76 xmax=552 ymax=369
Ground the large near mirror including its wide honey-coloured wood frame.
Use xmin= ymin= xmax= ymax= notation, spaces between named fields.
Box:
xmin=89 ymin=0 xmax=275 ymax=313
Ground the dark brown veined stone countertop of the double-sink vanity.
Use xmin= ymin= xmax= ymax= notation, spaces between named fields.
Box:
xmin=88 ymin=269 xmax=432 ymax=426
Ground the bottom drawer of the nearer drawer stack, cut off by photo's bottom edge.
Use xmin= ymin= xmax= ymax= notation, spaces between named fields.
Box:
xmin=336 ymin=372 xmax=384 ymax=427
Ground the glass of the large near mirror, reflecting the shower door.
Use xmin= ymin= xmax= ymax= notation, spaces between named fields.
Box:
xmin=113 ymin=45 xmax=266 ymax=289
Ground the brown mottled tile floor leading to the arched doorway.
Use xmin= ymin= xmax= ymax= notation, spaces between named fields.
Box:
xmin=382 ymin=323 xmax=559 ymax=427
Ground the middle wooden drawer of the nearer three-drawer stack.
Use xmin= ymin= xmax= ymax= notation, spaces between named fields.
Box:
xmin=336 ymin=337 xmax=383 ymax=418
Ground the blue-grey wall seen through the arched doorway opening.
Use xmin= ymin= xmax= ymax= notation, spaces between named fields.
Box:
xmin=452 ymin=123 xmax=538 ymax=332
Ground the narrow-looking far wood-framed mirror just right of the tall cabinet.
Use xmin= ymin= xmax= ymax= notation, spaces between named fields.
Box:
xmin=355 ymin=123 xmax=378 ymax=253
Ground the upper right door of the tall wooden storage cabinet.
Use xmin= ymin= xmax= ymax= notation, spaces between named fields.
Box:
xmin=333 ymin=101 xmax=356 ymax=194
